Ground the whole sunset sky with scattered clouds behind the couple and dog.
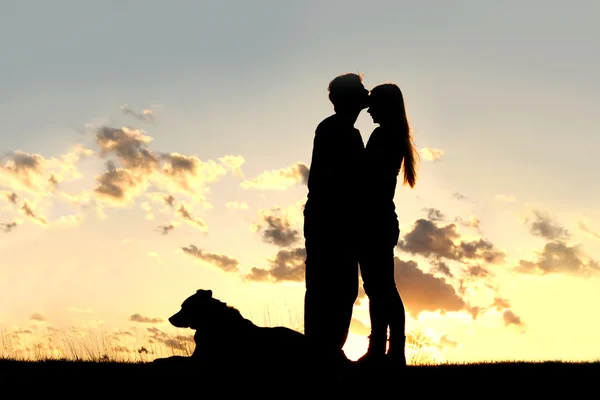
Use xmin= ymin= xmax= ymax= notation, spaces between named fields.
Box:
xmin=0 ymin=0 xmax=600 ymax=362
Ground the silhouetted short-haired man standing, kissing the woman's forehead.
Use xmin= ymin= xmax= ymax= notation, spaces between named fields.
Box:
xmin=304 ymin=73 xmax=369 ymax=366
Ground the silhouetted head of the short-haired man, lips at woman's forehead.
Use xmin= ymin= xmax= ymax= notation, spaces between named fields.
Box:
xmin=328 ymin=73 xmax=369 ymax=113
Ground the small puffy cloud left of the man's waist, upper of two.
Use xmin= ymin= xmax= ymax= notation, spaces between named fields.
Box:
xmin=256 ymin=207 xmax=302 ymax=247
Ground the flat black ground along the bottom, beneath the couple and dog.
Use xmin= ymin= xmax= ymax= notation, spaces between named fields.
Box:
xmin=0 ymin=360 xmax=600 ymax=398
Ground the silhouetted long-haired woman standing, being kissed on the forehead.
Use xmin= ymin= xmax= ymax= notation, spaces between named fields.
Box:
xmin=358 ymin=83 xmax=419 ymax=367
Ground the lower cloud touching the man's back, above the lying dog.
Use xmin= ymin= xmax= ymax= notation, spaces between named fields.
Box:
xmin=245 ymin=247 xmax=306 ymax=282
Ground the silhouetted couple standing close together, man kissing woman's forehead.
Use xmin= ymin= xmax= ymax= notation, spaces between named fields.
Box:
xmin=304 ymin=73 xmax=418 ymax=367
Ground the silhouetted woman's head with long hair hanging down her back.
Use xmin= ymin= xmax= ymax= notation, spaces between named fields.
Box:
xmin=367 ymin=83 xmax=419 ymax=188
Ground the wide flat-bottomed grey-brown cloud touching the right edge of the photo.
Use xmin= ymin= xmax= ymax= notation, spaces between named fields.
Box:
xmin=516 ymin=241 xmax=600 ymax=277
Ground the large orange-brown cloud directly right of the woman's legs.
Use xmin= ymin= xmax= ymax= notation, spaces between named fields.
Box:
xmin=394 ymin=257 xmax=467 ymax=317
